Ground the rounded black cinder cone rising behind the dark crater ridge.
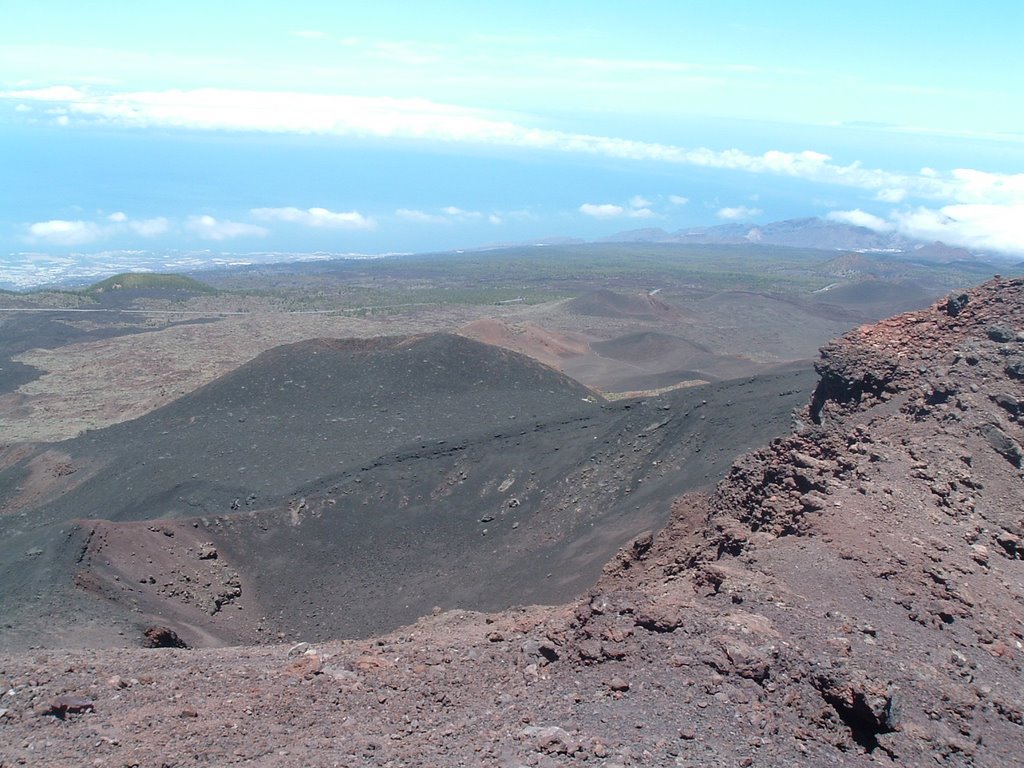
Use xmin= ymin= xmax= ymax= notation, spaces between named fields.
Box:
xmin=6 ymin=334 xmax=596 ymax=520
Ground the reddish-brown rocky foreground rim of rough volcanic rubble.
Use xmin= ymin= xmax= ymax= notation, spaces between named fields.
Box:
xmin=0 ymin=279 xmax=1024 ymax=767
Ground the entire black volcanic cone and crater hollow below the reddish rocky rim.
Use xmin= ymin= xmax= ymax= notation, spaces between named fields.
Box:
xmin=0 ymin=335 xmax=812 ymax=647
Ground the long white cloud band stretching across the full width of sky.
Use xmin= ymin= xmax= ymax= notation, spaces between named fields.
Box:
xmin=0 ymin=85 xmax=1024 ymax=217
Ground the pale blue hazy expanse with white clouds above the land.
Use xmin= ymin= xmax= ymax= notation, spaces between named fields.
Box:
xmin=0 ymin=0 xmax=1024 ymax=287
